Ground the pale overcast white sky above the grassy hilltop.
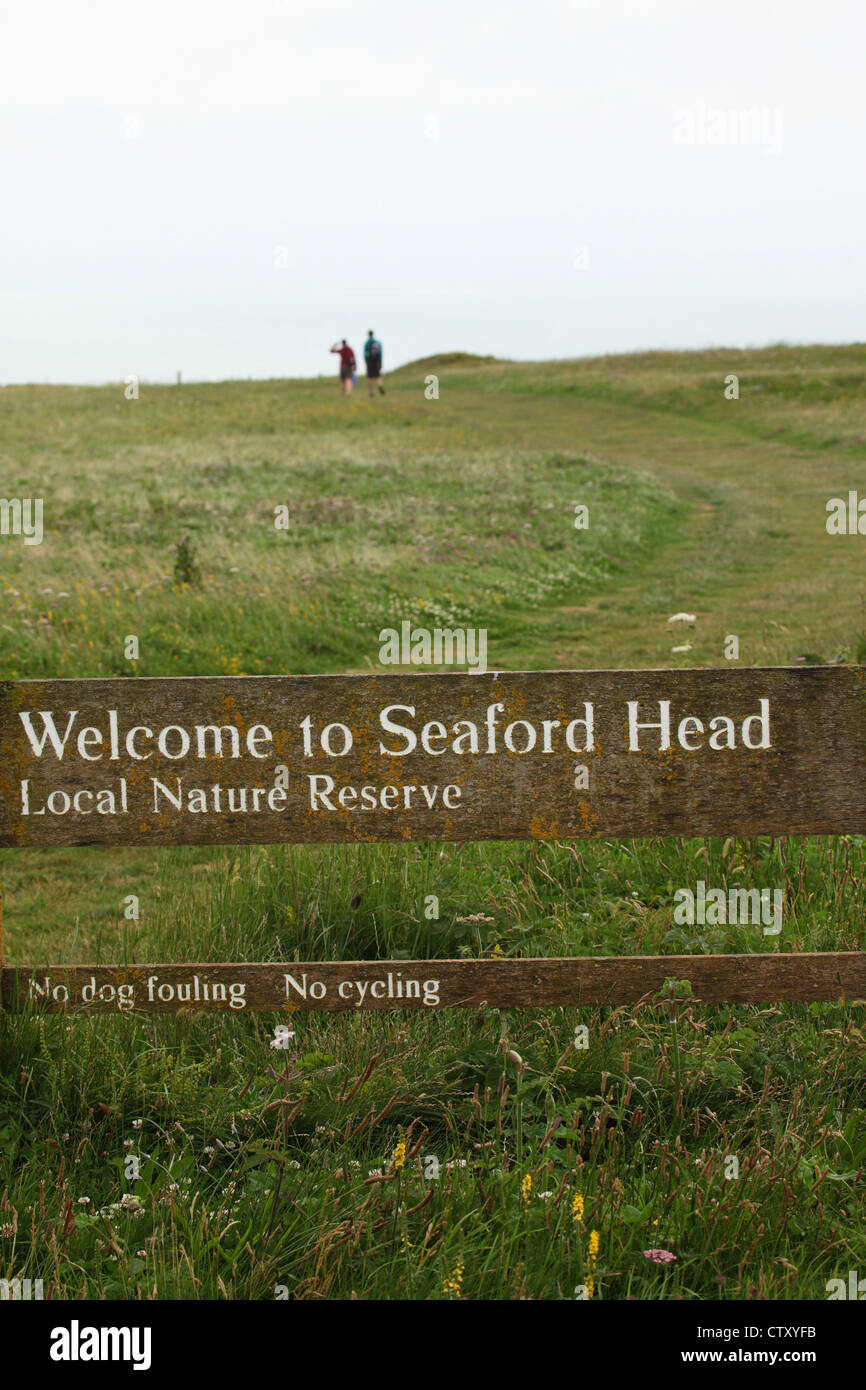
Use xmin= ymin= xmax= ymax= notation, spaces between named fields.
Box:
xmin=0 ymin=0 xmax=866 ymax=382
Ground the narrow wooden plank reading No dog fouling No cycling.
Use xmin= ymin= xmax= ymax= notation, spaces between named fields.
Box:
xmin=3 ymin=951 xmax=866 ymax=1013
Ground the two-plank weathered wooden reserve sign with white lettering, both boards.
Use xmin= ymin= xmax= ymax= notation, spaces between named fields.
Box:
xmin=0 ymin=667 xmax=866 ymax=1012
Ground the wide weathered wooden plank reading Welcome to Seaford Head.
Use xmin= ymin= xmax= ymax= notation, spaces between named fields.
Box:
xmin=0 ymin=667 xmax=866 ymax=845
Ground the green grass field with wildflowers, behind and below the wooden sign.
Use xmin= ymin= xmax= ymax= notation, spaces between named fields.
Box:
xmin=0 ymin=346 xmax=866 ymax=1300
